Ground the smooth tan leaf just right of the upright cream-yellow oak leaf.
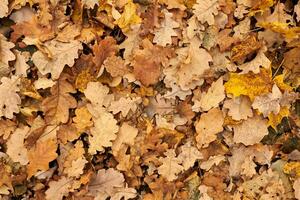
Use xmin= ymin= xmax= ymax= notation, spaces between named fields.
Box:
xmin=112 ymin=122 xmax=138 ymax=154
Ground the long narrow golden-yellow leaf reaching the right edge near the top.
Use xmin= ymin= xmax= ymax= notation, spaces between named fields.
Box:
xmin=258 ymin=22 xmax=300 ymax=39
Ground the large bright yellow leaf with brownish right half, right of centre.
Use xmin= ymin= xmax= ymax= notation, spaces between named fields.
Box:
xmin=224 ymin=69 xmax=273 ymax=101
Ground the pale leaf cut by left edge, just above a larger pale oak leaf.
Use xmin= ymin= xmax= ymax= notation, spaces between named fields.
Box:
xmin=0 ymin=34 xmax=16 ymax=77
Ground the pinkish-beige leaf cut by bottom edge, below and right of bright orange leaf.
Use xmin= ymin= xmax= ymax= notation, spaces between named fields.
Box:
xmin=45 ymin=176 xmax=72 ymax=200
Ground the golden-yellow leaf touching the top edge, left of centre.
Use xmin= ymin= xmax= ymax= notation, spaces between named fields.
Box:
xmin=115 ymin=1 xmax=141 ymax=30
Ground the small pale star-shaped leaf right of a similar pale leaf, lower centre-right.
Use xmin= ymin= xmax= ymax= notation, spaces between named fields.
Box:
xmin=178 ymin=141 xmax=203 ymax=170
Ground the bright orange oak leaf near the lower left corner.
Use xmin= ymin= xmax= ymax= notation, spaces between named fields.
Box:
xmin=27 ymin=139 xmax=57 ymax=179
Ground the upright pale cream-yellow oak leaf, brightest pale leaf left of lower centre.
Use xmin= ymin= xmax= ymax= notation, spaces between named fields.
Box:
xmin=89 ymin=111 xmax=119 ymax=155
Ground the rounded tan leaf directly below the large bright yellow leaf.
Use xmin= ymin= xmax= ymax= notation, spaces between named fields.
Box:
xmin=224 ymin=96 xmax=253 ymax=120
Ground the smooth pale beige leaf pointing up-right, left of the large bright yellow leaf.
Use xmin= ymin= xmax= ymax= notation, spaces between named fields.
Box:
xmin=200 ymin=77 xmax=225 ymax=111
